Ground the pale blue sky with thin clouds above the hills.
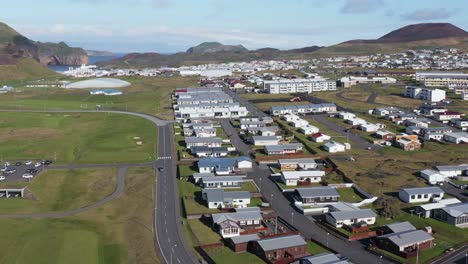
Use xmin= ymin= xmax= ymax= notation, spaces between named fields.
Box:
xmin=0 ymin=0 xmax=468 ymax=53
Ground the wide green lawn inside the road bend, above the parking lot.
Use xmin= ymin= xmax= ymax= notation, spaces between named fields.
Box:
xmin=0 ymin=112 xmax=156 ymax=164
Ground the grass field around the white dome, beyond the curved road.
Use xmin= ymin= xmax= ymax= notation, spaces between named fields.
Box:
xmin=0 ymin=76 xmax=197 ymax=119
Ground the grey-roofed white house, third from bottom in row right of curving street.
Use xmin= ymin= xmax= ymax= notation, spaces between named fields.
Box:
xmin=294 ymin=186 xmax=340 ymax=205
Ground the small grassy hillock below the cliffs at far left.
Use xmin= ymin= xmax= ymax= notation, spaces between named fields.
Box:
xmin=0 ymin=58 xmax=58 ymax=81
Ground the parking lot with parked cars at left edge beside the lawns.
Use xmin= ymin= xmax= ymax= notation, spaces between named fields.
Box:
xmin=0 ymin=160 xmax=52 ymax=182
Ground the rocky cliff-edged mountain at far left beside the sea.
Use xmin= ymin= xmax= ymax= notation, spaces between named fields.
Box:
xmin=0 ymin=22 xmax=88 ymax=65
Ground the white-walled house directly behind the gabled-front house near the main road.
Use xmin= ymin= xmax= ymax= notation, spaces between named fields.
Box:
xmin=202 ymin=189 xmax=250 ymax=209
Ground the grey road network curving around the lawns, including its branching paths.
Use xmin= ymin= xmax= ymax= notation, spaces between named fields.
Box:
xmin=0 ymin=109 xmax=199 ymax=264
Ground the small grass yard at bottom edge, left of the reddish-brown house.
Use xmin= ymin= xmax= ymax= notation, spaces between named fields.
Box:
xmin=205 ymin=247 xmax=265 ymax=264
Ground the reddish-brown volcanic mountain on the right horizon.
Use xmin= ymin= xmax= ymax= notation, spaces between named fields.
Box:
xmin=315 ymin=23 xmax=468 ymax=56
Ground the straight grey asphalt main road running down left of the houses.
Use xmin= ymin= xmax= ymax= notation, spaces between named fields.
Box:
xmin=154 ymin=125 xmax=198 ymax=264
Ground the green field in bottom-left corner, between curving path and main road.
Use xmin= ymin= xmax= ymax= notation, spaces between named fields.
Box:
xmin=0 ymin=168 xmax=160 ymax=264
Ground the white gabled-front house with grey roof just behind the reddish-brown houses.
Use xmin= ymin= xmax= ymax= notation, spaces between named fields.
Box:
xmin=211 ymin=207 xmax=263 ymax=238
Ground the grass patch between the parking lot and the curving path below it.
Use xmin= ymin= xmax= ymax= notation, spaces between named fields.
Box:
xmin=0 ymin=169 xmax=117 ymax=214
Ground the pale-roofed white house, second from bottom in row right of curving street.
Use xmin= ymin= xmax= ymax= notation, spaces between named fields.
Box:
xmin=325 ymin=209 xmax=376 ymax=228
